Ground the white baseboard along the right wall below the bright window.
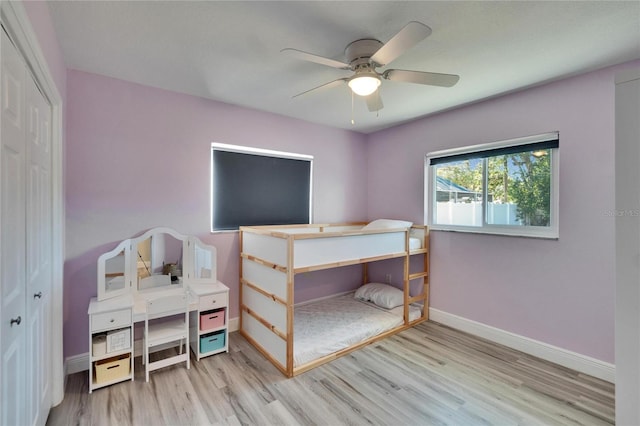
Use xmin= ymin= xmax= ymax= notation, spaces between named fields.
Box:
xmin=429 ymin=308 xmax=616 ymax=383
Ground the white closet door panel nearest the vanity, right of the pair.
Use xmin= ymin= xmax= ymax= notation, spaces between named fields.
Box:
xmin=26 ymin=66 xmax=52 ymax=425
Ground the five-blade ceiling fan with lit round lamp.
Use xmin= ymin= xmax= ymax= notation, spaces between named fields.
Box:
xmin=281 ymin=21 xmax=460 ymax=111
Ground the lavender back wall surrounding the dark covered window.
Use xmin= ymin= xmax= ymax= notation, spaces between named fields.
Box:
xmin=64 ymin=71 xmax=366 ymax=357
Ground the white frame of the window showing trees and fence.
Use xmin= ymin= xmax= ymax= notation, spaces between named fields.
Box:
xmin=424 ymin=132 xmax=560 ymax=239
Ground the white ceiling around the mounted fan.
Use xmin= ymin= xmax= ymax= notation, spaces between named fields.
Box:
xmin=49 ymin=0 xmax=640 ymax=133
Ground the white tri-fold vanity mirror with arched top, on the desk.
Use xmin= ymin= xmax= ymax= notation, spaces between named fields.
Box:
xmin=98 ymin=227 xmax=217 ymax=300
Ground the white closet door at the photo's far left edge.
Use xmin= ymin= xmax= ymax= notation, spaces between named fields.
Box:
xmin=0 ymin=32 xmax=27 ymax=425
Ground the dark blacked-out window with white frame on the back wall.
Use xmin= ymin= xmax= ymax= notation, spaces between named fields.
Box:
xmin=211 ymin=143 xmax=313 ymax=231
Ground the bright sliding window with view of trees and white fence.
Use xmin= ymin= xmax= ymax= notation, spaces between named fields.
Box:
xmin=425 ymin=132 xmax=559 ymax=238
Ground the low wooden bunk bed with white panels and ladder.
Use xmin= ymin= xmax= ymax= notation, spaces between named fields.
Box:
xmin=240 ymin=219 xmax=429 ymax=377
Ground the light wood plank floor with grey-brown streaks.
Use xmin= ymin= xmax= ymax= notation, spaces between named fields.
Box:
xmin=47 ymin=322 xmax=614 ymax=426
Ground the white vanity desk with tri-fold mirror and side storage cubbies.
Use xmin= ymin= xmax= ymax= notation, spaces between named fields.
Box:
xmin=88 ymin=228 xmax=229 ymax=392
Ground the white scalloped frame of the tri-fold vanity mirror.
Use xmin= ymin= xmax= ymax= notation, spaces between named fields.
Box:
xmin=97 ymin=227 xmax=217 ymax=300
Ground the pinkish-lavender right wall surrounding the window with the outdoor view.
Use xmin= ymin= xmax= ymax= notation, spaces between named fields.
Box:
xmin=367 ymin=62 xmax=638 ymax=363
